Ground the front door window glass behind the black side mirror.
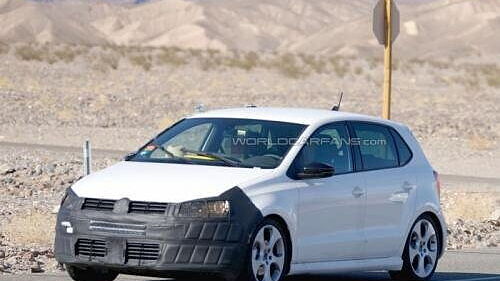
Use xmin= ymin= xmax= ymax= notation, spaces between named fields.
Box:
xmin=293 ymin=123 xmax=353 ymax=174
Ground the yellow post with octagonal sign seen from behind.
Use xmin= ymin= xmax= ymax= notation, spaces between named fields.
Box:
xmin=373 ymin=0 xmax=400 ymax=119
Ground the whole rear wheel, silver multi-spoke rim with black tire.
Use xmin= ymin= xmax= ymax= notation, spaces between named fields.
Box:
xmin=389 ymin=215 xmax=442 ymax=281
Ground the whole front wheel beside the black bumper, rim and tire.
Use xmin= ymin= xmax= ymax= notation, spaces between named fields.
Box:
xmin=239 ymin=219 xmax=291 ymax=281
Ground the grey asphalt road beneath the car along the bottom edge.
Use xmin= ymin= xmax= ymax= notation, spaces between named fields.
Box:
xmin=0 ymin=249 xmax=500 ymax=281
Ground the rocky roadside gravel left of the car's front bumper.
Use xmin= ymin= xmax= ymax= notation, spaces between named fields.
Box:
xmin=0 ymin=148 xmax=117 ymax=274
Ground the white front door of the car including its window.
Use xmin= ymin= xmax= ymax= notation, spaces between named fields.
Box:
xmin=291 ymin=122 xmax=366 ymax=263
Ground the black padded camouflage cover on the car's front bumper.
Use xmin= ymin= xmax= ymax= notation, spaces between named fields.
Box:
xmin=55 ymin=188 xmax=262 ymax=276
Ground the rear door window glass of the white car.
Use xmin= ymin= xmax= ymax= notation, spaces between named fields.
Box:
xmin=352 ymin=123 xmax=399 ymax=170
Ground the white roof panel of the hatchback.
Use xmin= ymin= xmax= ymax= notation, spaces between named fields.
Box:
xmin=188 ymin=107 xmax=401 ymax=126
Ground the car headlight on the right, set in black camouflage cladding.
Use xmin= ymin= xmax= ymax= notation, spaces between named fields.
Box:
xmin=178 ymin=198 xmax=230 ymax=218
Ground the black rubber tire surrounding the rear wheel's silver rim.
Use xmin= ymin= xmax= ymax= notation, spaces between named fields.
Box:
xmin=389 ymin=214 xmax=443 ymax=281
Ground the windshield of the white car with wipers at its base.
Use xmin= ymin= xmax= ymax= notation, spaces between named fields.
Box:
xmin=128 ymin=118 xmax=305 ymax=169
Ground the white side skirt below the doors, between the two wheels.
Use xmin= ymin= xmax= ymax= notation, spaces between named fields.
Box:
xmin=290 ymin=257 xmax=403 ymax=275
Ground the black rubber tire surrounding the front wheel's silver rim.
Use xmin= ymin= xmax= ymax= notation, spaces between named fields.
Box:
xmin=237 ymin=218 xmax=292 ymax=281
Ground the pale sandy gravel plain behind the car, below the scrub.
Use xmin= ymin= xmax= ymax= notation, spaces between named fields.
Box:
xmin=0 ymin=47 xmax=500 ymax=177
